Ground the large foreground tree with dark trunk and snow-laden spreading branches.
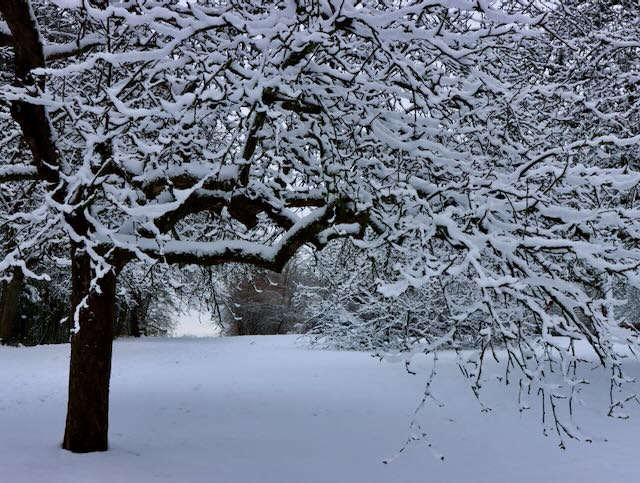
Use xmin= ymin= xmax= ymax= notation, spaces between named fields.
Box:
xmin=0 ymin=0 xmax=640 ymax=451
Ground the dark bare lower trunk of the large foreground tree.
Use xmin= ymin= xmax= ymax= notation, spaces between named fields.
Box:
xmin=62 ymin=250 xmax=116 ymax=453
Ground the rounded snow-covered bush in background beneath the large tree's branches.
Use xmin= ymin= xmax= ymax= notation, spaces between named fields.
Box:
xmin=296 ymin=240 xmax=456 ymax=353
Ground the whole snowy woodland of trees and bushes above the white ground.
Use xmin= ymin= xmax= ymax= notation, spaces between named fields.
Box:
xmin=0 ymin=0 xmax=640 ymax=464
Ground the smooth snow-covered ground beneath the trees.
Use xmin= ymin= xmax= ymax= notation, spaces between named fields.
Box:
xmin=0 ymin=336 xmax=640 ymax=483
